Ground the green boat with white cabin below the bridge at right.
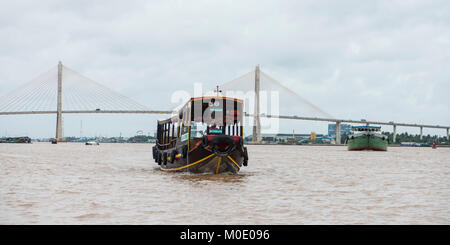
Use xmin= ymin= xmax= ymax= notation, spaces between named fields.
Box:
xmin=347 ymin=126 xmax=388 ymax=151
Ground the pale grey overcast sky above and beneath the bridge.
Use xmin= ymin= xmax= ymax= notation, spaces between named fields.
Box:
xmin=0 ymin=0 xmax=450 ymax=137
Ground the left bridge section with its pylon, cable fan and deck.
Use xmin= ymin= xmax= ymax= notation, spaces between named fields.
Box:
xmin=0 ymin=62 xmax=171 ymax=141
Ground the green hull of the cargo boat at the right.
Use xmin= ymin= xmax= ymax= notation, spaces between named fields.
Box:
xmin=348 ymin=135 xmax=387 ymax=151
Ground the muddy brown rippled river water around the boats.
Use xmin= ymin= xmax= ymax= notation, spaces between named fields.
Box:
xmin=0 ymin=143 xmax=450 ymax=224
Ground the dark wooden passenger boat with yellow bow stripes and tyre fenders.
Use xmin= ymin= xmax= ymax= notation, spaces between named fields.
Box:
xmin=153 ymin=96 xmax=248 ymax=174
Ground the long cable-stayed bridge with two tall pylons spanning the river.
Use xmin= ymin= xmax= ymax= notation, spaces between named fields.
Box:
xmin=0 ymin=62 xmax=450 ymax=142
